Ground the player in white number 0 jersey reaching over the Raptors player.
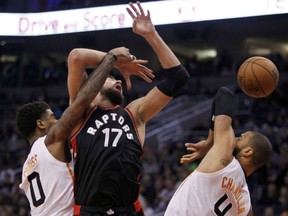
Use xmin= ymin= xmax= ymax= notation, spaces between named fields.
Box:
xmin=16 ymin=47 xmax=133 ymax=216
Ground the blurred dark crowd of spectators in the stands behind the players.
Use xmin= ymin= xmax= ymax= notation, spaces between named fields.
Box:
xmin=0 ymin=51 xmax=288 ymax=216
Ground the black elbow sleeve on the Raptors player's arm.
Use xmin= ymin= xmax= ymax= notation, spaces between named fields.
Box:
xmin=157 ymin=65 xmax=190 ymax=97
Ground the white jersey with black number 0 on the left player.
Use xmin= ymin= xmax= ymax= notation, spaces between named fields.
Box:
xmin=20 ymin=136 xmax=74 ymax=216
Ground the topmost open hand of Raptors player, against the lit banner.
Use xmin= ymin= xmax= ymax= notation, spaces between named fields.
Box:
xmin=126 ymin=1 xmax=156 ymax=37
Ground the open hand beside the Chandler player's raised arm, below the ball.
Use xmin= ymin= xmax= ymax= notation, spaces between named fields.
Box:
xmin=180 ymin=140 xmax=210 ymax=164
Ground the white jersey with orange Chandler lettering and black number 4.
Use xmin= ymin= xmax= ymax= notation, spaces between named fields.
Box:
xmin=165 ymin=158 xmax=251 ymax=216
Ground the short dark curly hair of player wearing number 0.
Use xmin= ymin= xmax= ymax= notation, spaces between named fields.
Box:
xmin=16 ymin=101 xmax=50 ymax=138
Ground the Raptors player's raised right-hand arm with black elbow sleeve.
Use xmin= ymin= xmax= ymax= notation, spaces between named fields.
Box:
xmin=127 ymin=1 xmax=189 ymax=123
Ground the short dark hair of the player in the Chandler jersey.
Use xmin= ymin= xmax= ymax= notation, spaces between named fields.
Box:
xmin=249 ymin=131 xmax=272 ymax=168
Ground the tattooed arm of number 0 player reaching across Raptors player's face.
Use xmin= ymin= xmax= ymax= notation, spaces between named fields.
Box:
xmin=45 ymin=47 xmax=132 ymax=158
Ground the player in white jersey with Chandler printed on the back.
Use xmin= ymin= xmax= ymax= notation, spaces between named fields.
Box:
xmin=165 ymin=87 xmax=272 ymax=216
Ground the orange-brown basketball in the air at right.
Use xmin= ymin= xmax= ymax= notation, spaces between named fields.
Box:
xmin=237 ymin=56 xmax=279 ymax=98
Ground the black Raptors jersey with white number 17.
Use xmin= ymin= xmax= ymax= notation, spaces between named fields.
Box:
xmin=70 ymin=106 xmax=143 ymax=207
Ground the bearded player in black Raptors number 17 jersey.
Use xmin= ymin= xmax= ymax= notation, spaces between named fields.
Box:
xmin=68 ymin=2 xmax=189 ymax=216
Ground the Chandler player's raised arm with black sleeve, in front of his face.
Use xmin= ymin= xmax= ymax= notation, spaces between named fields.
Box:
xmin=197 ymin=87 xmax=236 ymax=173
